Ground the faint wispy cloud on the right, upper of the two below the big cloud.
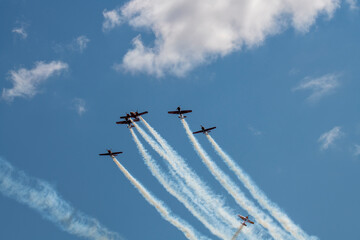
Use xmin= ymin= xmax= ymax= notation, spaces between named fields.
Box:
xmin=293 ymin=74 xmax=340 ymax=101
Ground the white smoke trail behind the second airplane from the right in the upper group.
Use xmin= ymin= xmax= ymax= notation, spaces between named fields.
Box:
xmin=181 ymin=119 xmax=289 ymax=240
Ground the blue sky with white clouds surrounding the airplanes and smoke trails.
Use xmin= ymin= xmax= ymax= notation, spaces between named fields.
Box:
xmin=0 ymin=0 xmax=360 ymax=239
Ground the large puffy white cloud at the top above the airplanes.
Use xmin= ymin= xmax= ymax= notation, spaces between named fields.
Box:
xmin=103 ymin=0 xmax=340 ymax=77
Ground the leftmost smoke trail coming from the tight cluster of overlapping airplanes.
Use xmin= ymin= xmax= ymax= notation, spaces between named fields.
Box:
xmin=130 ymin=129 xmax=229 ymax=239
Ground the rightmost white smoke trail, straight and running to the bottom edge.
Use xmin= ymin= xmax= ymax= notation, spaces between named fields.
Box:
xmin=206 ymin=135 xmax=309 ymax=240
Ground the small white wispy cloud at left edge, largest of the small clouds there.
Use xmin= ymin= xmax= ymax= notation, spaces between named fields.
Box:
xmin=2 ymin=61 xmax=68 ymax=101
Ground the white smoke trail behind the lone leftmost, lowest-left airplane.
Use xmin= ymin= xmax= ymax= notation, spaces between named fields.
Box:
xmin=112 ymin=156 xmax=206 ymax=240
